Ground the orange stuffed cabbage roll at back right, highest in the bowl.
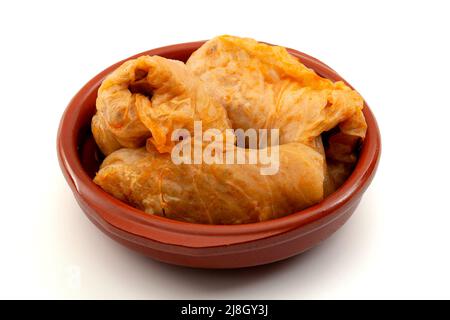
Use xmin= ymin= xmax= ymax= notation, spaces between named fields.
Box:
xmin=186 ymin=36 xmax=366 ymax=144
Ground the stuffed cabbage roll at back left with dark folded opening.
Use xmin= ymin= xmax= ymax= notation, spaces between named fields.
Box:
xmin=92 ymin=56 xmax=230 ymax=155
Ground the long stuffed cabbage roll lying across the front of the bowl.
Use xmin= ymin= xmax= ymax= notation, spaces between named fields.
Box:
xmin=94 ymin=143 xmax=324 ymax=224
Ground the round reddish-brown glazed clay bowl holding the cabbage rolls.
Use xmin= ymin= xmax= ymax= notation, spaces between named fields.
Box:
xmin=57 ymin=42 xmax=381 ymax=268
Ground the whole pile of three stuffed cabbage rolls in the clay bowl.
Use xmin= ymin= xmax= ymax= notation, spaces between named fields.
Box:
xmin=92 ymin=36 xmax=367 ymax=224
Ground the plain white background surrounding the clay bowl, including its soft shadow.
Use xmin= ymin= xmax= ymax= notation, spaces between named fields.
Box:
xmin=0 ymin=0 xmax=450 ymax=299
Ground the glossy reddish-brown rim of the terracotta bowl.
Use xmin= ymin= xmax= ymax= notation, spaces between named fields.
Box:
xmin=57 ymin=41 xmax=381 ymax=247
